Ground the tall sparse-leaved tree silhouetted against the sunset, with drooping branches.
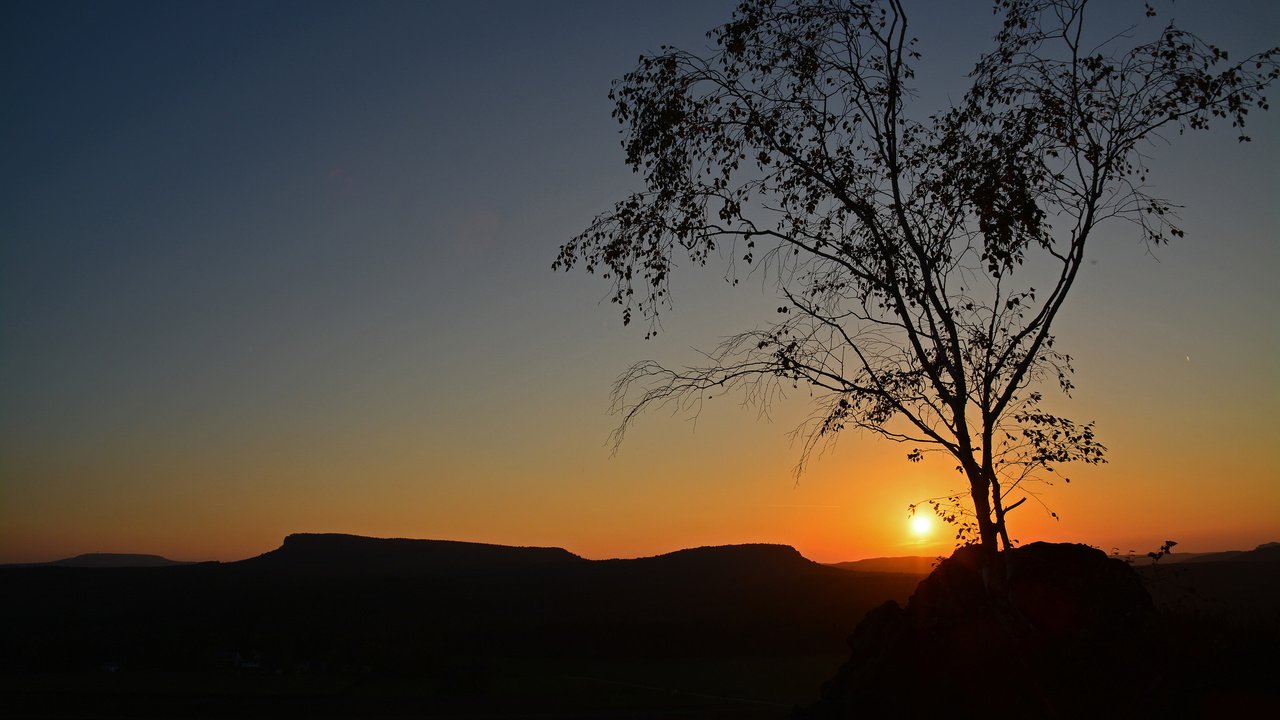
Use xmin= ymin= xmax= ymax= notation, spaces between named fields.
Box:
xmin=554 ymin=0 xmax=1280 ymax=551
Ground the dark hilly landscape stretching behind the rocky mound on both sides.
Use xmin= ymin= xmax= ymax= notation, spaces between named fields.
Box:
xmin=0 ymin=536 xmax=1280 ymax=719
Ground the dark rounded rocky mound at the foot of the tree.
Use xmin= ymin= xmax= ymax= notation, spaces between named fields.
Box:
xmin=797 ymin=543 xmax=1158 ymax=719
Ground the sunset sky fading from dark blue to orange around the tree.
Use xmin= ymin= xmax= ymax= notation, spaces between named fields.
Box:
xmin=0 ymin=0 xmax=1280 ymax=562
